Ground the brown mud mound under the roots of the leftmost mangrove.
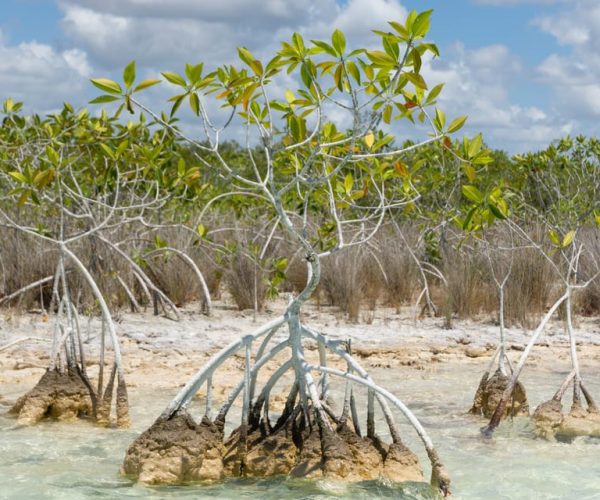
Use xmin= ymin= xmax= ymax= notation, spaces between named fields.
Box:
xmin=9 ymin=370 xmax=93 ymax=424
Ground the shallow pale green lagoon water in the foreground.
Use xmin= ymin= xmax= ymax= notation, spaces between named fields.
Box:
xmin=0 ymin=364 xmax=600 ymax=500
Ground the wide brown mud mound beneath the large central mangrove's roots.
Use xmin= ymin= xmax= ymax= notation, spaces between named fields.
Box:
xmin=122 ymin=414 xmax=423 ymax=484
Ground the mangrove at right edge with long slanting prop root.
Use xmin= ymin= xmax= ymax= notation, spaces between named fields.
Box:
xmin=473 ymin=137 xmax=600 ymax=439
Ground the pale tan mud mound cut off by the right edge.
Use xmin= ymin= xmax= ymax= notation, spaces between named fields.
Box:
xmin=531 ymin=399 xmax=600 ymax=440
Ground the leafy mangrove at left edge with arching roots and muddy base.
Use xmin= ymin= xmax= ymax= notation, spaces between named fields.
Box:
xmin=0 ymin=100 xmax=193 ymax=427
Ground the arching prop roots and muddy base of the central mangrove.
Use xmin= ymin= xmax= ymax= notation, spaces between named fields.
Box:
xmin=121 ymin=316 xmax=450 ymax=495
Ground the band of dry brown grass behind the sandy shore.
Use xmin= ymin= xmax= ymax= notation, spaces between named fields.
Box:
xmin=0 ymin=217 xmax=600 ymax=327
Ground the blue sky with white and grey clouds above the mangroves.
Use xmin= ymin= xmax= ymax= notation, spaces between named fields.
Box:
xmin=0 ymin=0 xmax=600 ymax=153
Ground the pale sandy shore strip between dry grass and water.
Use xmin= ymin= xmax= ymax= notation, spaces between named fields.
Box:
xmin=0 ymin=301 xmax=600 ymax=401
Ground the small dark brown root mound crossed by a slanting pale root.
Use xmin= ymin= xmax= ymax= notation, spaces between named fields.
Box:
xmin=469 ymin=370 xmax=529 ymax=418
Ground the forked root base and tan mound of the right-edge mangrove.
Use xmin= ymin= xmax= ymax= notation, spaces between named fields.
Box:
xmin=531 ymin=373 xmax=600 ymax=441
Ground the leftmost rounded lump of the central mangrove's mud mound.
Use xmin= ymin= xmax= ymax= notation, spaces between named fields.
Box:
xmin=121 ymin=412 xmax=224 ymax=484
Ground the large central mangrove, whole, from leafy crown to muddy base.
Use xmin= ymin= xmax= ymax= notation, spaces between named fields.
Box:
xmin=86 ymin=11 xmax=490 ymax=495
